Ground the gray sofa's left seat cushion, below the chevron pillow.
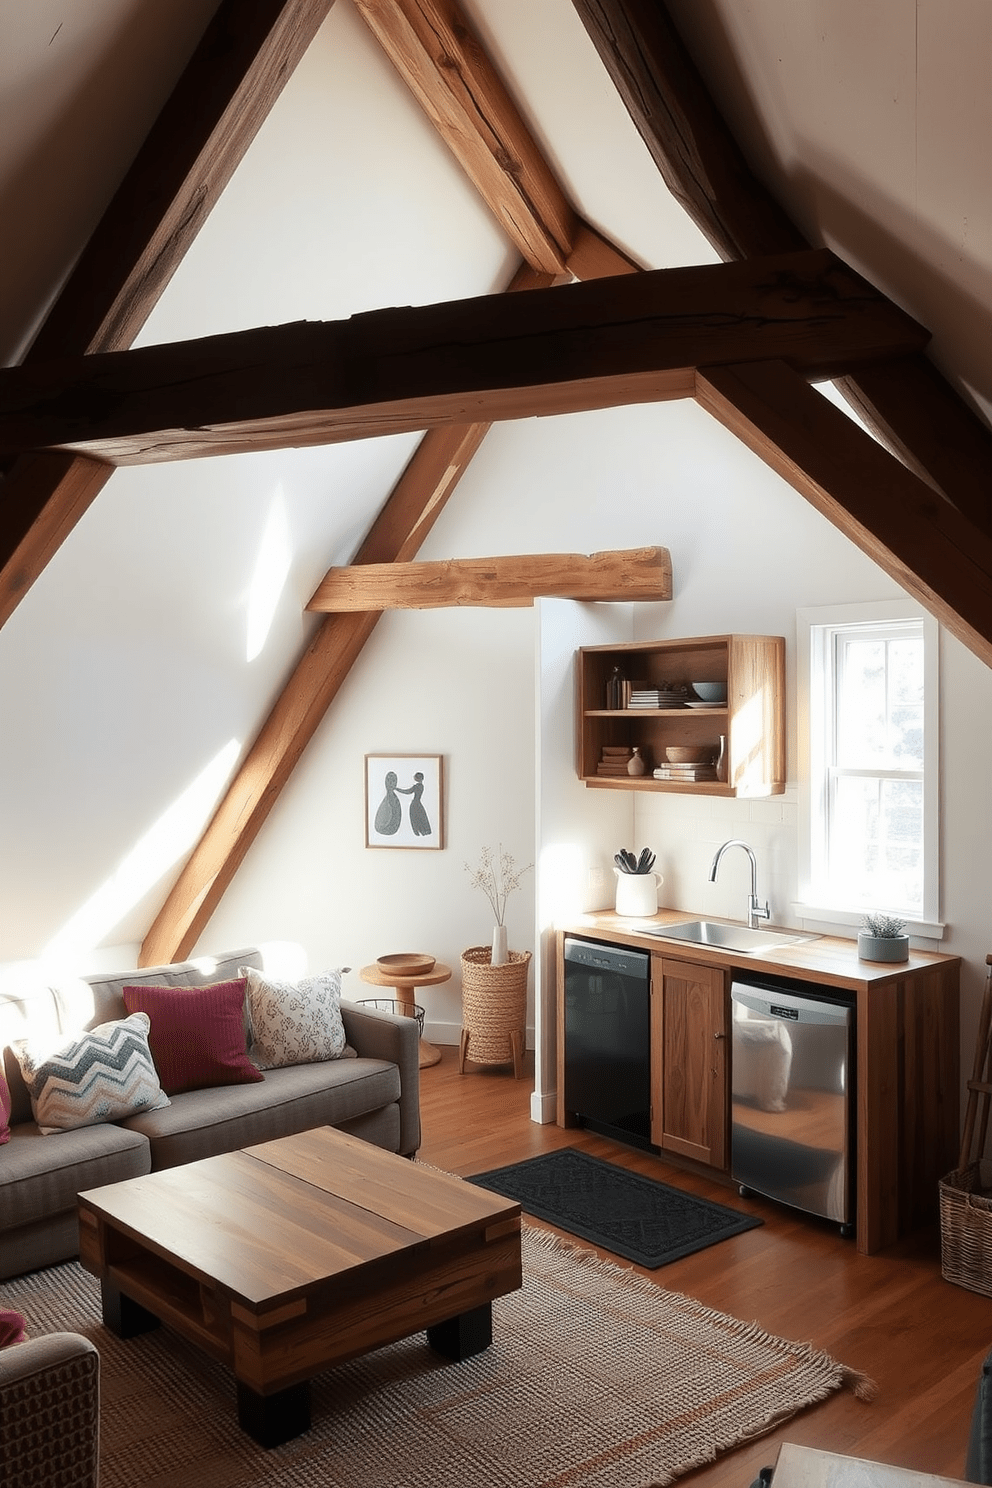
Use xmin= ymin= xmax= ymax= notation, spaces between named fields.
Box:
xmin=0 ymin=1122 xmax=152 ymax=1226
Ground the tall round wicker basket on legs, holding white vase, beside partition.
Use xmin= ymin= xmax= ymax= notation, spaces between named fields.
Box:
xmin=458 ymin=945 xmax=531 ymax=1080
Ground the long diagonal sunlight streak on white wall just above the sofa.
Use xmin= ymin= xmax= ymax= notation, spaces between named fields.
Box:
xmin=42 ymin=740 xmax=241 ymax=961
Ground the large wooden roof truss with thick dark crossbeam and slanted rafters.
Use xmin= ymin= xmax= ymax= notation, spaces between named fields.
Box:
xmin=0 ymin=0 xmax=992 ymax=964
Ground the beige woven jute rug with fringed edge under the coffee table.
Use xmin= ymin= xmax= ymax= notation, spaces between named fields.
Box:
xmin=0 ymin=1226 xmax=872 ymax=1488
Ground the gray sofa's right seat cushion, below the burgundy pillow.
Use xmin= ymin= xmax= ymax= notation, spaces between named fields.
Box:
xmin=123 ymin=1058 xmax=400 ymax=1170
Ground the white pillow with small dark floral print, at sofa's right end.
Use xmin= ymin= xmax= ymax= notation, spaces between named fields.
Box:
xmin=238 ymin=966 xmax=345 ymax=1070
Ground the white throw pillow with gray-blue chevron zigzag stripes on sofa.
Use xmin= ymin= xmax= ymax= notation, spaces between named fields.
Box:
xmin=10 ymin=1013 xmax=171 ymax=1137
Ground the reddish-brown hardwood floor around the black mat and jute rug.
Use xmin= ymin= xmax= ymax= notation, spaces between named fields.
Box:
xmin=419 ymin=1048 xmax=992 ymax=1488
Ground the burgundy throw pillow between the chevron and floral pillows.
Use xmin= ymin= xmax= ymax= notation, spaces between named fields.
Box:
xmin=123 ymin=978 xmax=263 ymax=1095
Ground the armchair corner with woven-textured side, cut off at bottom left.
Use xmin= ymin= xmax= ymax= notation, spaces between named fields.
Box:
xmin=0 ymin=1333 xmax=100 ymax=1488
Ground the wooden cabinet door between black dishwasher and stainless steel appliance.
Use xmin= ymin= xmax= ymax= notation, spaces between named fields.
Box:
xmin=651 ymin=955 xmax=729 ymax=1168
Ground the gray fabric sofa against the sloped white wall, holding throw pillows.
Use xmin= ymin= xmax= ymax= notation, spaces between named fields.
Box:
xmin=0 ymin=948 xmax=421 ymax=1278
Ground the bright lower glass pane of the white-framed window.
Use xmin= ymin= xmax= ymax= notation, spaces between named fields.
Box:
xmin=830 ymin=775 xmax=924 ymax=914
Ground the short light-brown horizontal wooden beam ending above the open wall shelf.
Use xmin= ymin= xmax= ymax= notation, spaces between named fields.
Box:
xmin=306 ymin=548 xmax=672 ymax=615
